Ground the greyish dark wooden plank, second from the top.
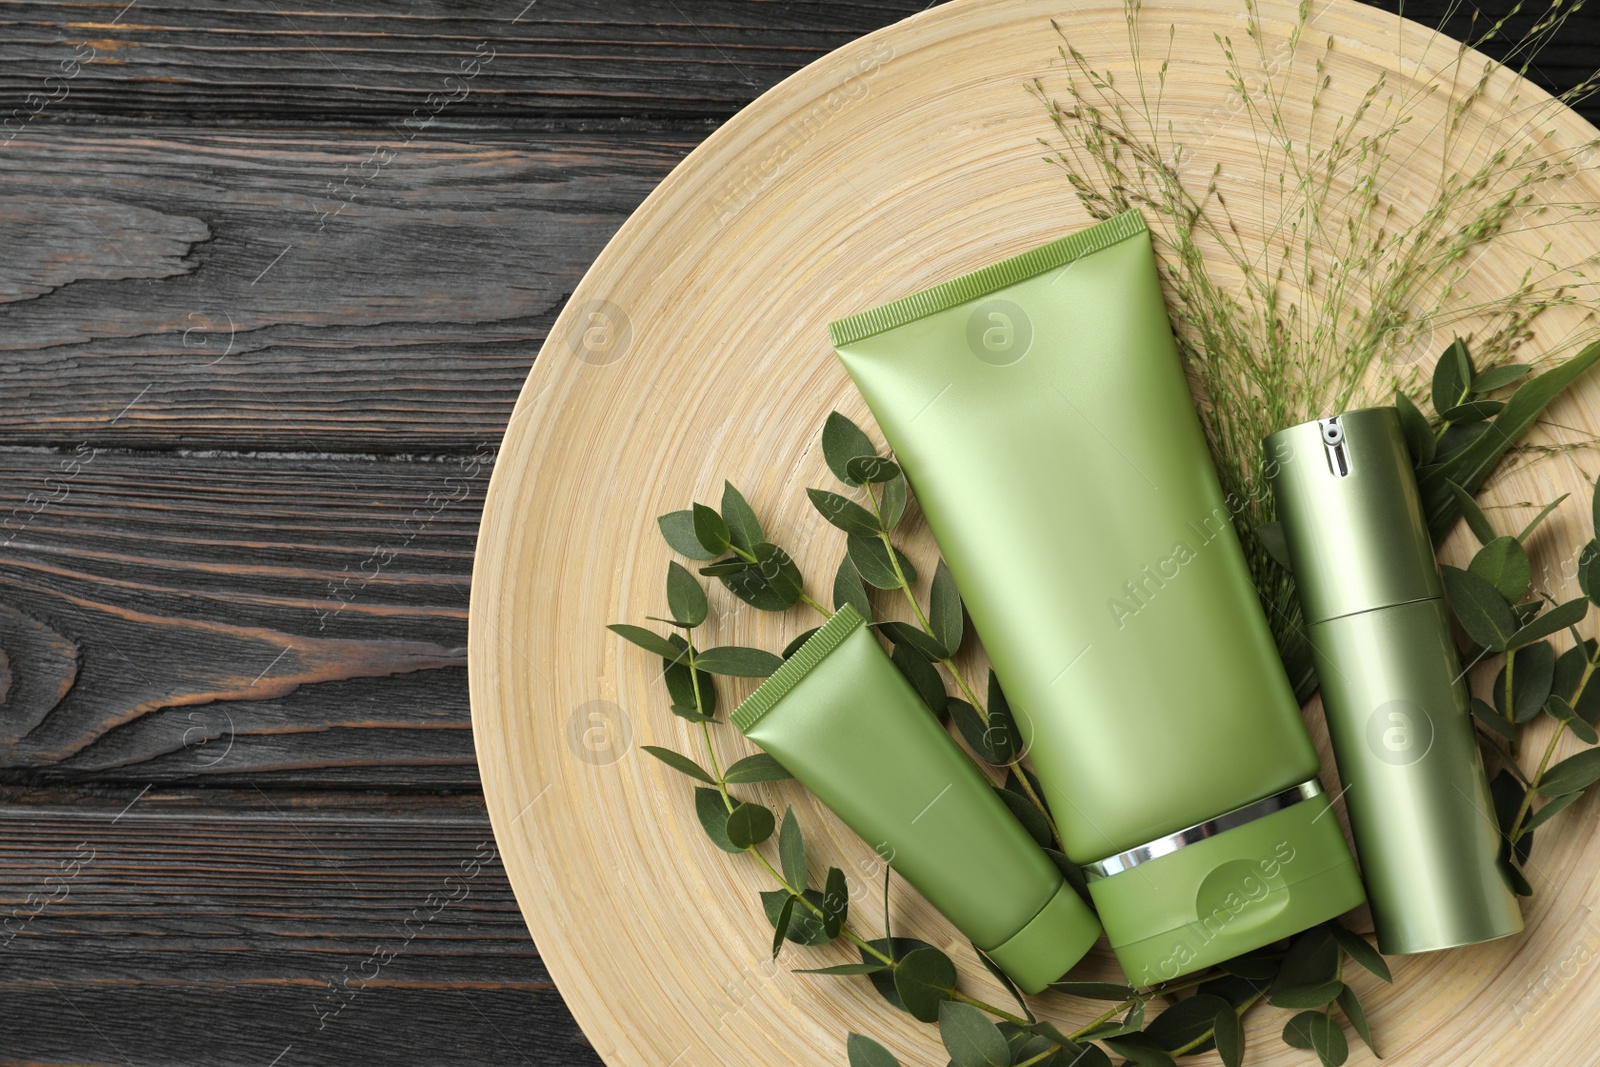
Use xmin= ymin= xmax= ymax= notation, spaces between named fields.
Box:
xmin=0 ymin=130 xmax=691 ymax=453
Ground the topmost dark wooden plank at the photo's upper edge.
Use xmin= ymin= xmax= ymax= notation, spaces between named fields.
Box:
xmin=0 ymin=0 xmax=930 ymax=128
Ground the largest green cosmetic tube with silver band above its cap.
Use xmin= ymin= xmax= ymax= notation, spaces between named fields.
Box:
xmin=830 ymin=211 xmax=1363 ymax=985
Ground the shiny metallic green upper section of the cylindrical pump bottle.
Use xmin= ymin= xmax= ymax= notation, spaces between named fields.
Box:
xmin=1264 ymin=408 xmax=1445 ymax=625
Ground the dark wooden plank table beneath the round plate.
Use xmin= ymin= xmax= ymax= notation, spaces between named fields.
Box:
xmin=0 ymin=0 xmax=1595 ymax=1067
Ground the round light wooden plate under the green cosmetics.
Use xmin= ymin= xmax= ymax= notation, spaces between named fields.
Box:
xmin=470 ymin=0 xmax=1600 ymax=1067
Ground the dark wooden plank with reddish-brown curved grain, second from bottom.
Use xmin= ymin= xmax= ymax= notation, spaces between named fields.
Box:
xmin=0 ymin=448 xmax=493 ymax=787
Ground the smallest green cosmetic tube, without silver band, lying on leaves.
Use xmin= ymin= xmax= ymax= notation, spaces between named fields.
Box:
xmin=733 ymin=605 xmax=1101 ymax=993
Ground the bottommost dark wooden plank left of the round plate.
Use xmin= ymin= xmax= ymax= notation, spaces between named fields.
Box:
xmin=0 ymin=790 xmax=598 ymax=1067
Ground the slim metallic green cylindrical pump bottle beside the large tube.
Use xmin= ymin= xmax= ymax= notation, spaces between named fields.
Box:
xmin=1264 ymin=408 xmax=1522 ymax=953
